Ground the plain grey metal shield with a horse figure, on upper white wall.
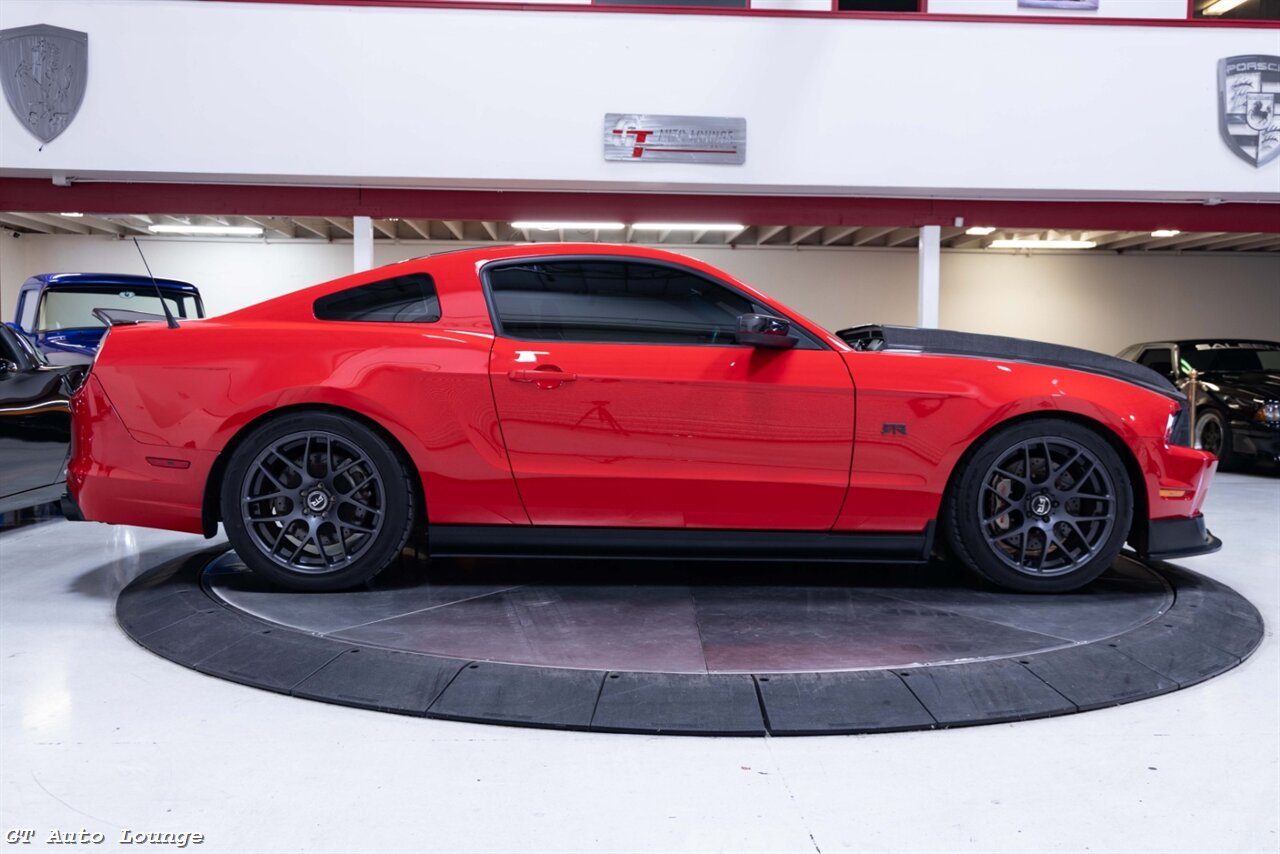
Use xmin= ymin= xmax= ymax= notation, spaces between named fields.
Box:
xmin=0 ymin=24 xmax=88 ymax=142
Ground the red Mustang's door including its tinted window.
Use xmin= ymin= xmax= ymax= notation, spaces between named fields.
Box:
xmin=484 ymin=257 xmax=854 ymax=530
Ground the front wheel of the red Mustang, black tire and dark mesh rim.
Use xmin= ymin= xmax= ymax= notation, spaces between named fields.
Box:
xmin=943 ymin=419 xmax=1133 ymax=593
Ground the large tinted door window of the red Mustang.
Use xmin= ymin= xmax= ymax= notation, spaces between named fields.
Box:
xmin=488 ymin=260 xmax=765 ymax=344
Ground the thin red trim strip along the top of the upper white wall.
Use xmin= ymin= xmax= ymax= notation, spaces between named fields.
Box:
xmin=220 ymin=0 xmax=1280 ymax=28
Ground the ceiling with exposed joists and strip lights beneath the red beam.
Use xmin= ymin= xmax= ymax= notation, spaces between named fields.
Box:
xmin=0 ymin=211 xmax=1280 ymax=254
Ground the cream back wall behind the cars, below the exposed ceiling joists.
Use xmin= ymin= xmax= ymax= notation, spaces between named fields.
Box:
xmin=0 ymin=233 xmax=1280 ymax=353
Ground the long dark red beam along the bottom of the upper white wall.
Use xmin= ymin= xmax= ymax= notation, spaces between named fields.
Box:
xmin=0 ymin=178 xmax=1280 ymax=233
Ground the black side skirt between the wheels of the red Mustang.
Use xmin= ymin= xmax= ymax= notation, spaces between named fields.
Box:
xmin=429 ymin=522 xmax=934 ymax=563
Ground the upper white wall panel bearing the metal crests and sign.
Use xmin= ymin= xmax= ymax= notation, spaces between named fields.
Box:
xmin=0 ymin=0 xmax=1280 ymax=201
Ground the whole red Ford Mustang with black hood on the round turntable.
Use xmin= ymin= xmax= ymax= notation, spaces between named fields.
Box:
xmin=68 ymin=245 xmax=1220 ymax=592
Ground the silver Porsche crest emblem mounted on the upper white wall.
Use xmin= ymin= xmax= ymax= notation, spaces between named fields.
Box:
xmin=1217 ymin=54 xmax=1280 ymax=166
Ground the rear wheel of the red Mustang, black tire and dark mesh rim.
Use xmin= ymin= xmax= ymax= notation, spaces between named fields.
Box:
xmin=221 ymin=412 xmax=413 ymax=590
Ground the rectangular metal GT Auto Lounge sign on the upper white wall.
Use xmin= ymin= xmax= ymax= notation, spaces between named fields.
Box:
xmin=604 ymin=113 xmax=746 ymax=165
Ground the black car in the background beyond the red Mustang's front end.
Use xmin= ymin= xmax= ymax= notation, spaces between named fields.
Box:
xmin=1119 ymin=338 xmax=1280 ymax=466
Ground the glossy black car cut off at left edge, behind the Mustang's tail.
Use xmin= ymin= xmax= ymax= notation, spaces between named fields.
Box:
xmin=0 ymin=325 xmax=90 ymax=513
